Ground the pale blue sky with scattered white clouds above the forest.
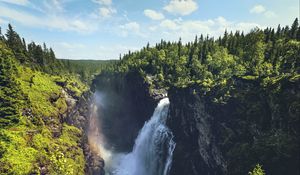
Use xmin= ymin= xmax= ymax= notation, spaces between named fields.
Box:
xmin=0 ymin=0 xmax=300 ymax=60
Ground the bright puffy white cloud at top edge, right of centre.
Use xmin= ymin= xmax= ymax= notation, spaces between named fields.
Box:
xmin=164 ymin=0 xmax=198 ymax=16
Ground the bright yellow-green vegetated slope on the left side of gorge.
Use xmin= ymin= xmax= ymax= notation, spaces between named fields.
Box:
xmin=0 ymin=37 xmax=88 ymax=175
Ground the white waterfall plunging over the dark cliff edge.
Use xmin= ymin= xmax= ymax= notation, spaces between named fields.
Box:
xmin=108 ymin=98 xmax=175 ymax=175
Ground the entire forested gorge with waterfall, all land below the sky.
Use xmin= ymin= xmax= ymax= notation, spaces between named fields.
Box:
xmin=0 ymin=19 xmax=300 ymax=175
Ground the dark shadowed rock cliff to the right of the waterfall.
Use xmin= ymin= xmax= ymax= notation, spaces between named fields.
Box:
xmin=168 ymin=78 xmax=300 ymax=175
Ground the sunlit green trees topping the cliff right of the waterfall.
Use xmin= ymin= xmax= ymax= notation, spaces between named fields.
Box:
xmin=106 ymin=20 xmax=300 ymax=96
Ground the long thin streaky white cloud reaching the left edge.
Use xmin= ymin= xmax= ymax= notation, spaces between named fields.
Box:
xmin=0 ymin=6 xmax=95 ymax=33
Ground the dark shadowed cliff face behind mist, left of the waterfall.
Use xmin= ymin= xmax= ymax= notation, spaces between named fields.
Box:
xmin=93 ymin=72 xmax=158 ymax=152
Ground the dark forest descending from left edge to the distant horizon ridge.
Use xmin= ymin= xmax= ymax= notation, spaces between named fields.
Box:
xmin=0 ymin=24 xmax=114 ymax=80
